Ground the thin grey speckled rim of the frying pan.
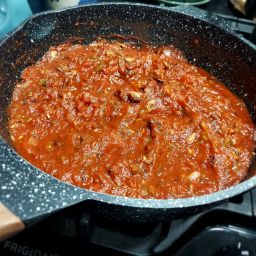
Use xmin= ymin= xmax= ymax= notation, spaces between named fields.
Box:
xmin=0 ymin=2 xmax=256 ymax=209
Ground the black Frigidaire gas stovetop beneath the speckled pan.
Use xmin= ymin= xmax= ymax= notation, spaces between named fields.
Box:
xmin=0 ymin=0 xmax=256 ymax=256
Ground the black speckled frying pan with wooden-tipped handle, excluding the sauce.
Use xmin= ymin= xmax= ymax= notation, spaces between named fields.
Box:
xmin=0 ymin=3 xmax=256 ymax=242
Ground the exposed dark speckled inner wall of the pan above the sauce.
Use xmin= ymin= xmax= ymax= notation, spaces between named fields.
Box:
xmin=0 ymin=4 xmax=256 ymax=180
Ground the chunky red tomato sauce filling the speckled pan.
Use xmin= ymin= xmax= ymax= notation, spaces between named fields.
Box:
xmin=8 ymin=40 xmax=255 ymax=198
